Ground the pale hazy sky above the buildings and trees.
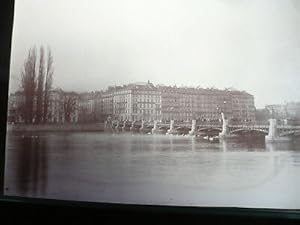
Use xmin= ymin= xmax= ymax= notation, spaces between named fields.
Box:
xmin=11 ymin=0 xmax=300 ymax=107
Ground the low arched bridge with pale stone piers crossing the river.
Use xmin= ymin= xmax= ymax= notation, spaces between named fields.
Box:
xmin=104 ymin=114 xmax=300 ymax=142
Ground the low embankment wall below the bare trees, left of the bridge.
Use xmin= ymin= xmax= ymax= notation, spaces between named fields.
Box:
xmin=7 ymin=123 xmax=104 ymax=132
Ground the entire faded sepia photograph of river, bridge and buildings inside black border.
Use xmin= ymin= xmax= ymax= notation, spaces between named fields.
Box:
xmin=4 ymin=0 xmax=300 ymax=209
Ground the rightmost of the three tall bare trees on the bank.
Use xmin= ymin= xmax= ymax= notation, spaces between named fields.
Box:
xmin=43 ymin=48 xmax=54 ymax=123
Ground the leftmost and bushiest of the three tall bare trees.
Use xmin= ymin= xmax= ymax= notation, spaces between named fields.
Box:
xmin=21 ymin=47 xmax=37 ymax=123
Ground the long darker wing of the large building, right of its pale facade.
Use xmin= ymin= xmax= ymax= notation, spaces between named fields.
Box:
xmin=159 ymin=86 xmax=255 ymax=122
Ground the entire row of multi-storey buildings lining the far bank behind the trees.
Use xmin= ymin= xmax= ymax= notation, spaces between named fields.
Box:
xmin=9 ymin=81 xmax=255 ymax=123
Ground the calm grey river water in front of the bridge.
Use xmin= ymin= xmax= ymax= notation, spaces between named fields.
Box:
xmin=5 ymin=132 xmax=300 ymax=209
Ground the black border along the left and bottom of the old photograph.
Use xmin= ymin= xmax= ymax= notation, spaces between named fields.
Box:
xmin=0 ymin=0 xmax=300 ymax=224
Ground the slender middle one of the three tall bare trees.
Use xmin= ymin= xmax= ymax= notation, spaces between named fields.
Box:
xmin=35 ymin=46 xmax=45 ymax=123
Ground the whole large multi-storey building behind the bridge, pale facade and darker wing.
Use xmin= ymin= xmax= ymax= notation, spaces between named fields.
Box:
xmin=102 ymin=82 xmax=255 ymax=122
